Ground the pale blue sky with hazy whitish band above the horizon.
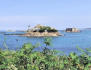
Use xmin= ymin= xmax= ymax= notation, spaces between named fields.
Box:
xmin=0 ymin=0 xmax=91 ymax=30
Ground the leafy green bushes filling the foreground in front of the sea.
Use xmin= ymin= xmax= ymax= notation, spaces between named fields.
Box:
xmin=0 ymin=38 xmax=91 ymax=70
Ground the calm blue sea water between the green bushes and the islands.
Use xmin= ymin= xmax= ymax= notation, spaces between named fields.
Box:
xmin=0 ymin=29 xmax=91 ymax=54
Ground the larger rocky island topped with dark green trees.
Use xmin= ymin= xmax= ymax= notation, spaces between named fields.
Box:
xmin=21 ymin=24 xmax=62 ymax=37
